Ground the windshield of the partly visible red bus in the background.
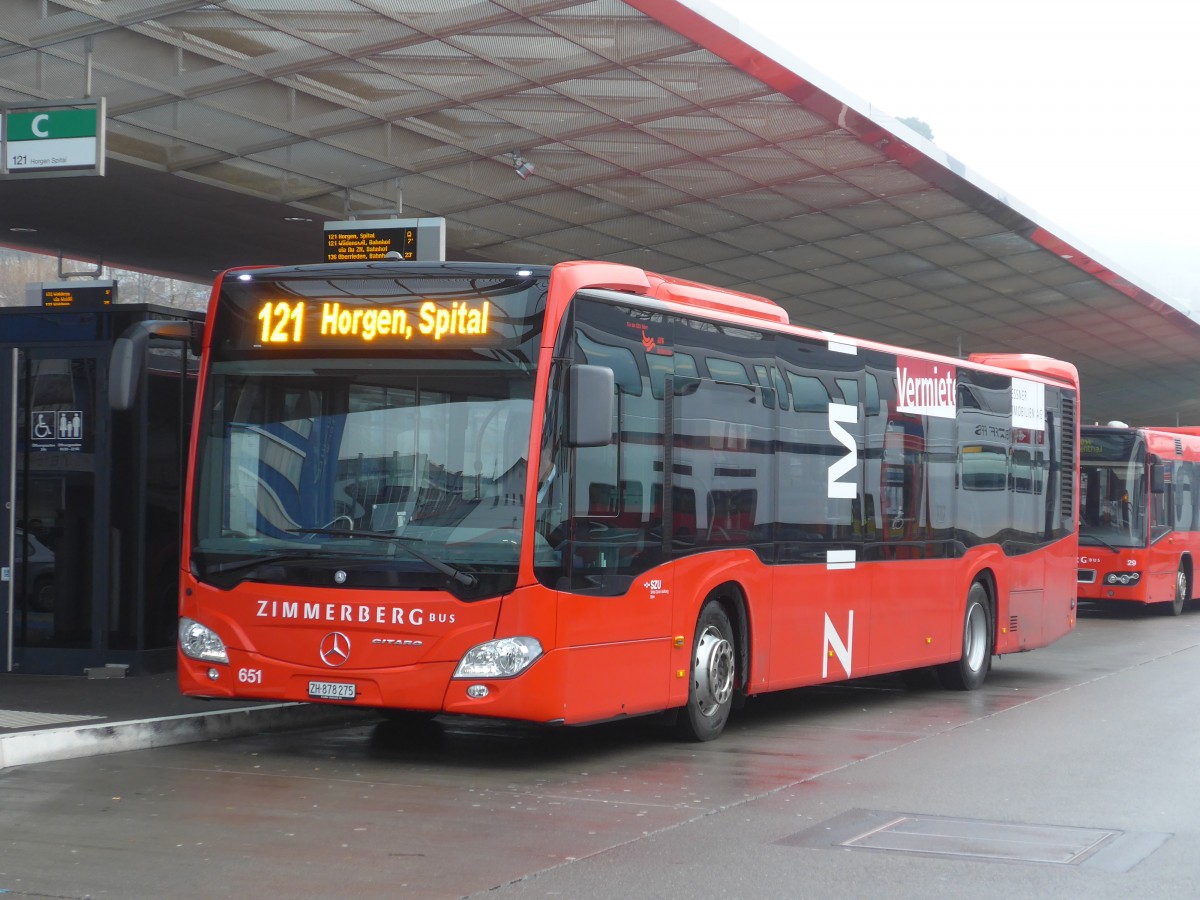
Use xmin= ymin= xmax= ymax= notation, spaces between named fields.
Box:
xmin=1079 ymin=432 xmax=1148 ymax=547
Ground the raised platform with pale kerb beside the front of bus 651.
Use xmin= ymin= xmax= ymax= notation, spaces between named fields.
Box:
xmin=0 ymin=666 xmax=368 ymax=772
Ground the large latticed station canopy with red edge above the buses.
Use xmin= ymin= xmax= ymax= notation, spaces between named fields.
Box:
xmin=0 ymin=0 xmax=1200 ymax=425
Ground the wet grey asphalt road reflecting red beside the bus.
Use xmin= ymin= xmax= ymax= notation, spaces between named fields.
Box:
xmin=0 ymin=612 xmax=1200 ymax=900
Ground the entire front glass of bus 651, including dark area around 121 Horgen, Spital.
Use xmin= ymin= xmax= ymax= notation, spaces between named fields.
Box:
xmin=191 ymin=267 xmax=545 ymax=599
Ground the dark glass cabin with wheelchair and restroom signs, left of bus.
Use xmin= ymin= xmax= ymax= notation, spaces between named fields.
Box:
xmin=0 ymin=304 xmax=203 ymax=674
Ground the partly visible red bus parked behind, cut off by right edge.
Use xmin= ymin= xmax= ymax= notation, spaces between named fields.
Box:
xmin=1079 ymin=422 xmax=1200 ymax=616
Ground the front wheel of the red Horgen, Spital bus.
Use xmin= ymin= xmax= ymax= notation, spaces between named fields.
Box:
xmin=676 ymin=600 xmax=738 ymax=740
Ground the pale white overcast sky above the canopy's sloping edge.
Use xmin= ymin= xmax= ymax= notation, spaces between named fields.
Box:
xmin=712 ymin=0 xmax=1200 ymax=301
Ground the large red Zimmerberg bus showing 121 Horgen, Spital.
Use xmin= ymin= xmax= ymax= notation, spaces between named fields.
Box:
xmin=113 ymin=262 xmax=1078 ymax=740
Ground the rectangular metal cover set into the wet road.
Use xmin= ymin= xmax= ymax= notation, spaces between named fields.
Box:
xmin=776 ymin=810 xmax=1171 ymax=872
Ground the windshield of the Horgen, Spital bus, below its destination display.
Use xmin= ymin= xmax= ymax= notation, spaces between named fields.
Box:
xmin=192 ymin=362 xmax=533 ymax=600
